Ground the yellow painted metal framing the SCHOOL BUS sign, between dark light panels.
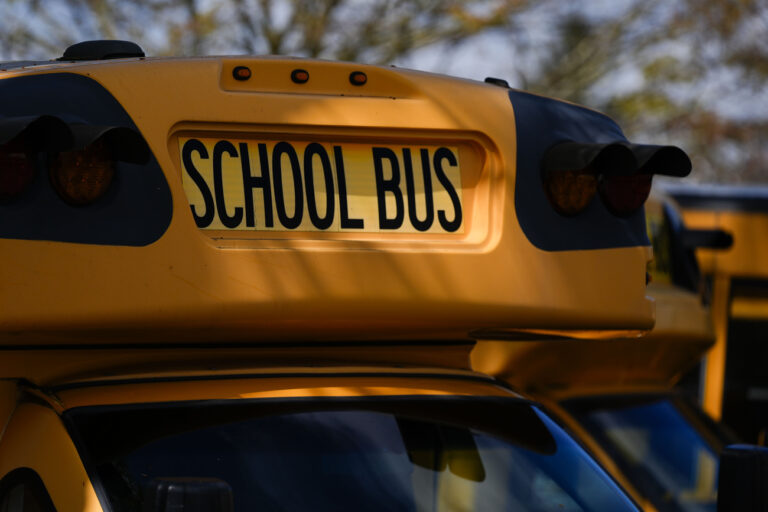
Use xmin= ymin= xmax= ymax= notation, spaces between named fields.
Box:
xmin=0 ymin=58 xmax=653 ymax=345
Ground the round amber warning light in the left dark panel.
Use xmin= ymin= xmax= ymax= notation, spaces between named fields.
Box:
xmin=49 ymin=139 xmax=115 ymax=206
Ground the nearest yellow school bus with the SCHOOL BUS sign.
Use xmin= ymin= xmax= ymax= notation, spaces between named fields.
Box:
xmin=0 ymin=41 xmax=690 ymax=512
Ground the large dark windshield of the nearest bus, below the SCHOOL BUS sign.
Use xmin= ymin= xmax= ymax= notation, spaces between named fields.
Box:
xmin=66 ymin=397 xmax=637 ymax=512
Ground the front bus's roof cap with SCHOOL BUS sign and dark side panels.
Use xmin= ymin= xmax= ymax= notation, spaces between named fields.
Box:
xmin=0 ymin=57 xmax=653 ymax=346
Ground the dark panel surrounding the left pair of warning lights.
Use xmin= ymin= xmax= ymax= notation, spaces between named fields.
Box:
xmin=0 ymin=73 xmax=173 ymax=246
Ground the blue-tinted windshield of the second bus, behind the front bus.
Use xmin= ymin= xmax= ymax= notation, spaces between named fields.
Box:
xmin=563 ymin=395 xmax=728 ymax=512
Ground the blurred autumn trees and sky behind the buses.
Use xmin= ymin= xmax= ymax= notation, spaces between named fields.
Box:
xmin=0 ymin=0 xmax=768 ymax=182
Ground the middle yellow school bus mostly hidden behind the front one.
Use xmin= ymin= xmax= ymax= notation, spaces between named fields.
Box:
xmin=472 ymin=196 xmax=735 ymax=512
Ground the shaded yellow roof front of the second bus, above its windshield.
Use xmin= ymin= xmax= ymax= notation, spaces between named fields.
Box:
xmin=472 ymin=283 xmax=714 ymax=391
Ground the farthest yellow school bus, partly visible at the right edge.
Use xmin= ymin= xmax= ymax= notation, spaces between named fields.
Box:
xmin=668 ymin=185 xmax=768 ymax=444
